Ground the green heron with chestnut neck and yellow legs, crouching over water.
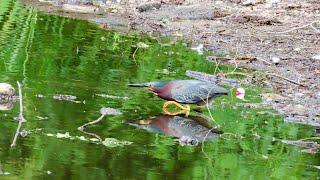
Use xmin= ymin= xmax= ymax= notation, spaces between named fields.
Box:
xmin=129 ymin=80 xmax=229 ymax=116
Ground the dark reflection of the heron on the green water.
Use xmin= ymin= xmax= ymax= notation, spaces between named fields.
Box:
xmin=124 ymin=115 xmax=222 ymax=146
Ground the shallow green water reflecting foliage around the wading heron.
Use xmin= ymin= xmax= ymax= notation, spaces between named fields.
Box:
xmin=0 ymin=0 xmax=320 ymax=179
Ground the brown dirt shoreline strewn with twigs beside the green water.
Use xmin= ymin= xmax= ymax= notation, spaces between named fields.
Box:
xmin=21 ymin=0 xmax=320 ymax=126
